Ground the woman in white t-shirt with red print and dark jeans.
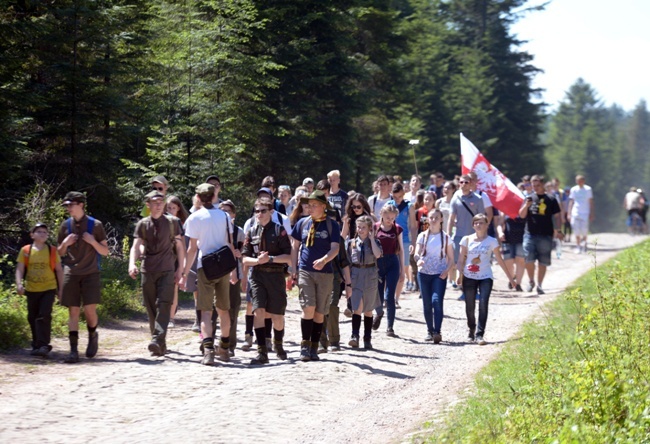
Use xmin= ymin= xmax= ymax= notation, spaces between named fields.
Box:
xmin=458 ymin=213 xmax=517 ymax=345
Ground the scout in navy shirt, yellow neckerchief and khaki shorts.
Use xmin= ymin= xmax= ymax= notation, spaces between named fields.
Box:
xmin=291 ymin=190 xmax=341 ymax=361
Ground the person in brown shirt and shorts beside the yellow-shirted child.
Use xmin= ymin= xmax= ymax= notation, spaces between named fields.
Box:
xmin=57 ymin=191 xmax=108 ymax=364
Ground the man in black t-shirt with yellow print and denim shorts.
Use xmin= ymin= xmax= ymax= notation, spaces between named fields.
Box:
xmin=519 ymin=175 xmax=563 ymax=295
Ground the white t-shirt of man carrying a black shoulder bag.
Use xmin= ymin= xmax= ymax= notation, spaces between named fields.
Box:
xmin=183 ymin=207 xmax=232 ymax=270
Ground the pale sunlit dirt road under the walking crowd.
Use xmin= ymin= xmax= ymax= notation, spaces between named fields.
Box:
xmin=0 ymin=234 xmax=642 ymax=443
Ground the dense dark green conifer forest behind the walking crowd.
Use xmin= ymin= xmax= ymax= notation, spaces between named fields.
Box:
xmin=0 ymin=0 xmax=650 ymax=252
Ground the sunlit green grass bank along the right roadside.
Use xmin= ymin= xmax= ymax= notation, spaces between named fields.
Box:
xmin=426 ymin=242 xmax=650 ymax=443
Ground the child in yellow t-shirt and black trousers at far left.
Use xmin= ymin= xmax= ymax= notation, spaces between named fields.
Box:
xmin=16 ymin=223 xmax=63 ymax=358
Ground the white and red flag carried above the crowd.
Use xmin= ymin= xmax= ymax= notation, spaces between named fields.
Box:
xmin=460 ymin=133 xmax=524 ymax=218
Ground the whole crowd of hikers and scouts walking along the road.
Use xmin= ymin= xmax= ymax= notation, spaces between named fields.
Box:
xmin=16 ymin=170 xmax=632 ymax=365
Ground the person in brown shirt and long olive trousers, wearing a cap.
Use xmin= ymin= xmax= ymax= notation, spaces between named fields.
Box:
xmin=129 ymin=190 xmax=185 ymax=356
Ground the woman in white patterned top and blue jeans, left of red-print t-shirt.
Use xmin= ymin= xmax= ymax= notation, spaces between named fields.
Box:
xmin=415 ymin=208 xmax=454 ymax=344
